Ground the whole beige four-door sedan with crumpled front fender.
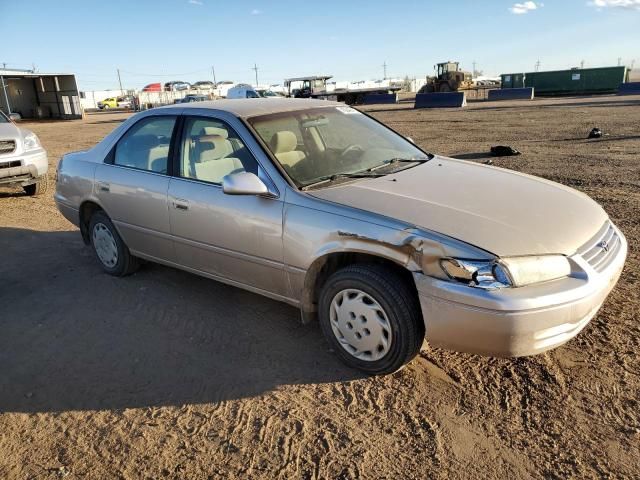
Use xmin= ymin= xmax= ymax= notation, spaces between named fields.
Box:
xmin=55 ymin=99 xmax=627 ymax=374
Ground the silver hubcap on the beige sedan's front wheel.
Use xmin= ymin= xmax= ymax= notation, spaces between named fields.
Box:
xmin=330 ymin=288 xmax=392 ymax=362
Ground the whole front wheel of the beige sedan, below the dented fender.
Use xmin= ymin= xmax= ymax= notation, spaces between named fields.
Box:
xmin=319 ymin=264 xmax=424 ymax=375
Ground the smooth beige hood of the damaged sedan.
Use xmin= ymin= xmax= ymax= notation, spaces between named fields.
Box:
xmin=308 ymin=157 xmax=607 ymax=256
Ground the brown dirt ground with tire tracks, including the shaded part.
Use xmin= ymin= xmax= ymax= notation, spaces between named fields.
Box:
xmin=0 ymin=96 xmax=640 ymax=479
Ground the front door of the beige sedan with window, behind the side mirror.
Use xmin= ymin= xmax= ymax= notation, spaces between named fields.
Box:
xmin=169 ymin=116 xmax=286 ymax=295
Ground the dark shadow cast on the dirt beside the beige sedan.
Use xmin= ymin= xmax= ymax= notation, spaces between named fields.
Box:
xmin=0 ymin=228 xmax=359 ymax=412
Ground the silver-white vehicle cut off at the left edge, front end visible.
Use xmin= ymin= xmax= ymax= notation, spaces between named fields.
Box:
xmin=0 ymin=112 xmax=49 ymax=195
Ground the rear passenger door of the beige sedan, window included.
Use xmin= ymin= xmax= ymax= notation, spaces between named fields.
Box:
xmin=95 ymin=115 xmax=178 ymax=261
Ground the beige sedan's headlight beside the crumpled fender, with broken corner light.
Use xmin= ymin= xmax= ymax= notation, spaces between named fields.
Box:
xmin=440 ymin=255 xmax=571 ymax=288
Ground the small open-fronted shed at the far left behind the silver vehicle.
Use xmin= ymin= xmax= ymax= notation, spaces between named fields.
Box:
xmin=0 ymin=69 xmax=82 ymax=120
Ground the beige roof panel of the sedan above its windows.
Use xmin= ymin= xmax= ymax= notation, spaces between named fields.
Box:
xmin=156 ymin=98 xmax=345 ymax=118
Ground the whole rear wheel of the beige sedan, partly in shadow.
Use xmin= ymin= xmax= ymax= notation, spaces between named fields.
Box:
xmin=89 ymin=211 xmax=140 ymax=277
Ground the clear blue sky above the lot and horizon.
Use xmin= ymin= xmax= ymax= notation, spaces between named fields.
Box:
xmin=0 ymin=0 xmax=640 ymax=90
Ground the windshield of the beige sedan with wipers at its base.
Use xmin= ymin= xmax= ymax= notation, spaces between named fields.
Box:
xmin=249 ymin=106 xmax=428 ymax=187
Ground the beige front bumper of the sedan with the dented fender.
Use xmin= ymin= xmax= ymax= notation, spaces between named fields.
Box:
xmin=414 ymin=225 xmax=627 ymax=357
